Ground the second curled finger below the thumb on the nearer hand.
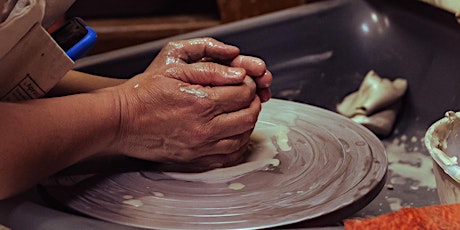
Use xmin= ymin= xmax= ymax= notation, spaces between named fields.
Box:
xmin=209 ymin=96 xmax=261 ymax=140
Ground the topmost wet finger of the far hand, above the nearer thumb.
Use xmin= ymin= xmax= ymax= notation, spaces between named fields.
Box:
xmin=169 ymin=38 xmax=240 ymax=63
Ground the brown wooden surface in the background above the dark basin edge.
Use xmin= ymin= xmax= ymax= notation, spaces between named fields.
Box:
xmin=67 ymin=0 xmax=305 ymax=54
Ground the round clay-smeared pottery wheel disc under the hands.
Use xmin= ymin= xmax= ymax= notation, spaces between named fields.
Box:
xmin=44 ymin=99 xmax=388 ymax=229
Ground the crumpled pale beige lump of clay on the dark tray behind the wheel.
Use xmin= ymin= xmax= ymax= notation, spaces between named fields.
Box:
xmin=337 ymin=70 xmax=407 ymax=136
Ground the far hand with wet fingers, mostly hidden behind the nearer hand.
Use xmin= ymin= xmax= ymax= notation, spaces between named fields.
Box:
xmin=146 ymin=38 xmax=272 ymax=102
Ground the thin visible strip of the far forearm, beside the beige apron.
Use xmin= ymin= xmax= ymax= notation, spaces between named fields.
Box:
xmin=47 ymin=70 xmax=126 ymax=97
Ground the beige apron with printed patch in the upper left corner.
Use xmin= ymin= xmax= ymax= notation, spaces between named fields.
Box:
xmin=0 ymin=0 xmax=74 ymax=101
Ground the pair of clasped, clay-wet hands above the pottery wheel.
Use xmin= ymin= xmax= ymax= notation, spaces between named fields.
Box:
xmin=105 ymin=38 xmax=272 ymax=170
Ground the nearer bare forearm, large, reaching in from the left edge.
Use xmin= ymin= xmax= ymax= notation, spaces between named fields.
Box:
xmin=0 ymin=91 xmax=119 ymax=199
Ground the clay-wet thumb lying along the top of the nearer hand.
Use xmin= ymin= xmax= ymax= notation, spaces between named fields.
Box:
xmin=165 ymin=62 xmax=246 ymax=86
